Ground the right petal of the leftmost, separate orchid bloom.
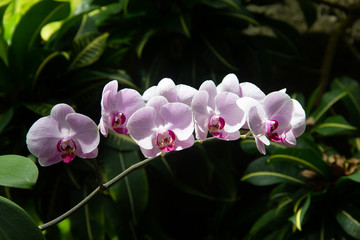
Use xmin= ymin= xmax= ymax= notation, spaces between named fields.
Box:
xmin=66 ymin=113 xmax=100 ymax=153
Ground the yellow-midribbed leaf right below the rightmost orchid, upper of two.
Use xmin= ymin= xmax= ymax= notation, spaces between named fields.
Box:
xmin=268 ymin=148 xmax=330 ymax=177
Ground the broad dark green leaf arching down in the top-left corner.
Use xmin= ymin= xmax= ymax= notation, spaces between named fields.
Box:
xmin=9 ymin=1 xmax=70 ymax=74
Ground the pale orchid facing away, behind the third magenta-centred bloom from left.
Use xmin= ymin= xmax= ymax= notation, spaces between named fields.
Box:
xmin=143 ymin=78 xmax=197 ymax=106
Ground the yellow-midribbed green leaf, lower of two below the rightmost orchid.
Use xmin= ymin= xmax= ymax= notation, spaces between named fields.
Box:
xmin=241 ymin=157 xmax=305 ymax=186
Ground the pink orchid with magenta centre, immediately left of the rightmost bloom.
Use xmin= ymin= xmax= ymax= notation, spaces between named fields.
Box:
xmin=191 ymin=80 xmax=245 ymax=141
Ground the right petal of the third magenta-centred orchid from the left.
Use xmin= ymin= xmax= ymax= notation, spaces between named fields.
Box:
xmin=160 ymin=102 xmax=194 ymax=141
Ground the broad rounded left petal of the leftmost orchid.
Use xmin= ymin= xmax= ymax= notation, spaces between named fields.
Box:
xmin=26 ymin=116 xmax=62 ymax=159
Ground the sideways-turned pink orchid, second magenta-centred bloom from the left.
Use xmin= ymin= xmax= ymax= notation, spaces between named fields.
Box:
xmin=99 ymin=80 xmax=145 ymax=137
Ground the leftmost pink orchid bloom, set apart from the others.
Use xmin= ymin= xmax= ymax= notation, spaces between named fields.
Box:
xmin=26 ymin=104 xmax=100 ymax=166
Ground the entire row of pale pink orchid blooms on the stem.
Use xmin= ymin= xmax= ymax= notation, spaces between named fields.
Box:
xmin=26 ymin=74 xmax=305 ymax=166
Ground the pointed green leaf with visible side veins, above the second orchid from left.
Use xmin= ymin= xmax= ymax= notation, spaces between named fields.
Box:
xmin=68 ymin=33 xmax=109 ymax=71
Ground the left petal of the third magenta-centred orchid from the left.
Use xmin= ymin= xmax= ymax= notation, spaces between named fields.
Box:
xmin=127 ymin=107 xmax=157 ymax=149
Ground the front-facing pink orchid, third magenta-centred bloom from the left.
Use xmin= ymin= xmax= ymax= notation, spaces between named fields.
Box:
xmin=128 ymin=96 xmax=194 ymax=157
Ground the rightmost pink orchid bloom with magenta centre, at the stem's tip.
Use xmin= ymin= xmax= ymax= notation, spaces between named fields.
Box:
xmin=237 ymin=91 xmax=294 ymax=154
